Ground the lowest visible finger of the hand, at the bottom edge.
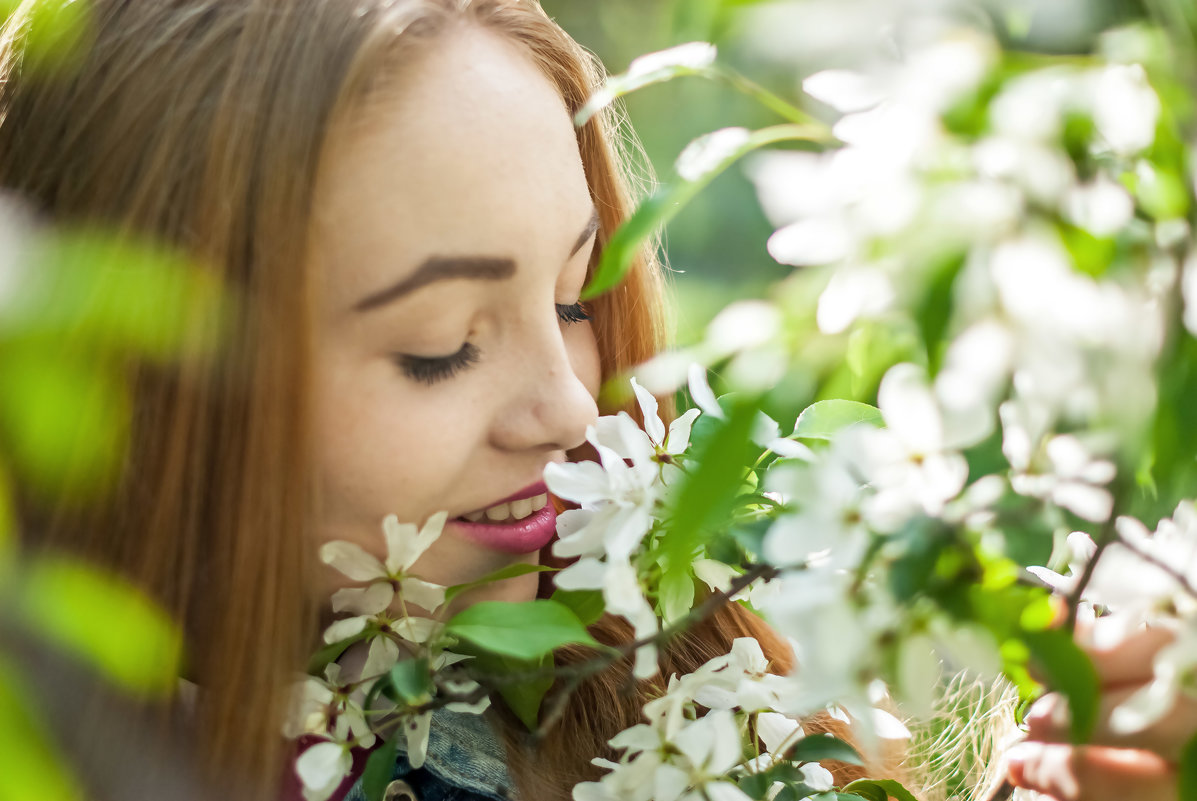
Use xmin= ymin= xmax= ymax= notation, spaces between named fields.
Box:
xmin=1007 ymin=742 xmax=1178 ymax=801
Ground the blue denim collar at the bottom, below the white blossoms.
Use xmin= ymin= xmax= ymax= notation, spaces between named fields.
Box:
xmin=345 ymin=709 xmax=517 ymax=801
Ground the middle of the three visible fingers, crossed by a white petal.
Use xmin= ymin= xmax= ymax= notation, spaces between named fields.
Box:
xmin=1026 ymin=687 xmax=1197 ymax=761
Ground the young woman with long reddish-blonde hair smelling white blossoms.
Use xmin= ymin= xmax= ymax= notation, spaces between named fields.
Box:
xmin=0 ymin=0 xmax=1187 ymax=801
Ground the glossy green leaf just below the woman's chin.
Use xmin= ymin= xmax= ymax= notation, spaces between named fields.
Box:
xmin=445 ymin=600 xmax=599 ymax=660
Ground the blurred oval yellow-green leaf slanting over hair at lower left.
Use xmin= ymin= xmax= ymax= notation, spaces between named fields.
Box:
xmin=17 ymin=557 xmax=182 ymax=696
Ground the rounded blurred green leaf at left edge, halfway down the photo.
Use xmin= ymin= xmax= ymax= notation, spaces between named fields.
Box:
xmin=0 ymin=345 xmax=130 ymax=497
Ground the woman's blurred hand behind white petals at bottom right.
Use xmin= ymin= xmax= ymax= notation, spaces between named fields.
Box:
xmin=1007 ymin=629 xmax=1197 ymax=801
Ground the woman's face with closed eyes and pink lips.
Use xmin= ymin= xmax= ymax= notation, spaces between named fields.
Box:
xmin=312 ymin=21 xmax=600 ymax=599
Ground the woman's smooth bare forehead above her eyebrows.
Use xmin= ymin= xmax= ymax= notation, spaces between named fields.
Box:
xmin=312 ymin=22 xmax=590 ymax=299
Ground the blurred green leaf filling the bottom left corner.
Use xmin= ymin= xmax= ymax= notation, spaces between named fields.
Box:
xmin=0 ymin=659 xmax=84 ymax=801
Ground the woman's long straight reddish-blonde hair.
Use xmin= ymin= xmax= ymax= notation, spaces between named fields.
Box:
xmin=0 ymin=0 xmax=880 ymax=799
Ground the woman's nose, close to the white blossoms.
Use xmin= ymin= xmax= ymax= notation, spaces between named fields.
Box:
xmin=491 ymin=326 xmax=599 ymax=451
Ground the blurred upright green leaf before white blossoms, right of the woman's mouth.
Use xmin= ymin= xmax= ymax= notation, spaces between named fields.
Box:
xmin=661 ymin=398 xmax=759 ymax=593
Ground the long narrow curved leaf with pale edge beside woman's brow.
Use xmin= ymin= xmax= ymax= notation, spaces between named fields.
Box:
xmin=582 ymin=125 xmax=827 ymax=301
